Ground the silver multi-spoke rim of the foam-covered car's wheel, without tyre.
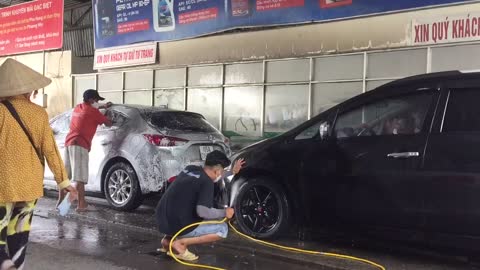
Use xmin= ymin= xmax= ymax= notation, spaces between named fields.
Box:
xmin=108 ymin=169 xmax=132 ymax=205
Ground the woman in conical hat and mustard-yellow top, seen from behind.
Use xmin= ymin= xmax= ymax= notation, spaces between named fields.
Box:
xmin=0 ymin=58 xmax=76 ymax=270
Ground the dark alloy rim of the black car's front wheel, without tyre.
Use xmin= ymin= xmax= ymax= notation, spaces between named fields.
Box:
xmin=240 ymin=186 xmax=280 ymax=234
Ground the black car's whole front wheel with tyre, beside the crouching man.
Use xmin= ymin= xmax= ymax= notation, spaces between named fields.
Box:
xmin=234 ymin=178 xmax=290 ymax=239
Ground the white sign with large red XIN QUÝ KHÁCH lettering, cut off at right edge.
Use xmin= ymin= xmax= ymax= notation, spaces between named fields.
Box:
xmin=411 ymin=13 xmax=480 ymax=45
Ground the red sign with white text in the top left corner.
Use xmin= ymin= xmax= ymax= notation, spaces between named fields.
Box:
xmin=0 ymin=0 xmax=63 ymax=55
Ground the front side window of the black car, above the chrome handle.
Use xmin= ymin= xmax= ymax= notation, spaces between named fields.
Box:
xmin=334 ymin=91 xmax=433 ymax=138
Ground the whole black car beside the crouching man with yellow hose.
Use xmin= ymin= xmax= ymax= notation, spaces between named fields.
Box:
xmin=226 ymin=71 xmax=480 ymax=251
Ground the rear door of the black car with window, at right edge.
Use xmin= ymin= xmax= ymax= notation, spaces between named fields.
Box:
xmin=424 ymin=87 xmax=480 ymax=237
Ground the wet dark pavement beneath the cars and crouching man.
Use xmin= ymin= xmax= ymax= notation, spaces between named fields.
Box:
xmin=27 ymin=193 xmax=477 ymax=270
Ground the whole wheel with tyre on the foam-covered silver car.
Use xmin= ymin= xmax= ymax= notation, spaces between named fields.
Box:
xmin=103 ymin=162 xmax=143 ymax=211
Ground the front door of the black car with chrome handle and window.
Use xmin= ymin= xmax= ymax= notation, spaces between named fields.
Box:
xmin=334 ymin=86 xmax=439 ymax=231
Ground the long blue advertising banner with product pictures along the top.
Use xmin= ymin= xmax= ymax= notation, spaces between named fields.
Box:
xmin=93 ymin=0 xmax=473 ymax=49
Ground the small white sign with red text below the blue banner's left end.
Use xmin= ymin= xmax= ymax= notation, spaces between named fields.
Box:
xmin=93 ymin=43 xmax=157 ymax=69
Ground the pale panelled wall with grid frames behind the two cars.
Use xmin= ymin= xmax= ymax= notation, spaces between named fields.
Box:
xmin=73 ymin=43 xmax=480 ymax=150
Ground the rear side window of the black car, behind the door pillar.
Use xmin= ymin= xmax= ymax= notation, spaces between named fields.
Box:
xmin=442 ymin=89 xmax=480 ymax=132
